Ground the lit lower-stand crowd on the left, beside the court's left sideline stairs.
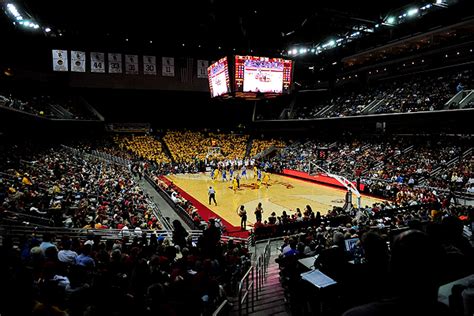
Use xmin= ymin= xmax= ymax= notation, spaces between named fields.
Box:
xmin=0 ymin=148 xmax=162 ymax=230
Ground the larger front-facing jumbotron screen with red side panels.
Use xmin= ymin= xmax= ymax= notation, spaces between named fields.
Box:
xmin=235 ymin=56 xmax=293 ymax=94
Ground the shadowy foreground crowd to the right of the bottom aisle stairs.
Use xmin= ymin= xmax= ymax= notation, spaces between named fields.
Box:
xmin=277 ymin=204 xmax=474 ymax=315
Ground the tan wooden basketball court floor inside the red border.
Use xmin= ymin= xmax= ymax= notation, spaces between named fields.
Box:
xmin=167 ymin=171 xmax=383 ymax=226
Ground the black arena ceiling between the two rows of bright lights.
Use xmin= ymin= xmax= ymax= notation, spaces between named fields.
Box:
xmin=9 ymin=0 xmax=420 ymax=53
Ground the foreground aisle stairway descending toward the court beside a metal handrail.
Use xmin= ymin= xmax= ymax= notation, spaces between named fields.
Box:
xmin=229 ymin=256 xmax=291 ymax=316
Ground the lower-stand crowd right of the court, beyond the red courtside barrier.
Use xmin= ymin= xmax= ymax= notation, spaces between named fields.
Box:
xmin=272 ymin=137 xmax=474 ymax=198
